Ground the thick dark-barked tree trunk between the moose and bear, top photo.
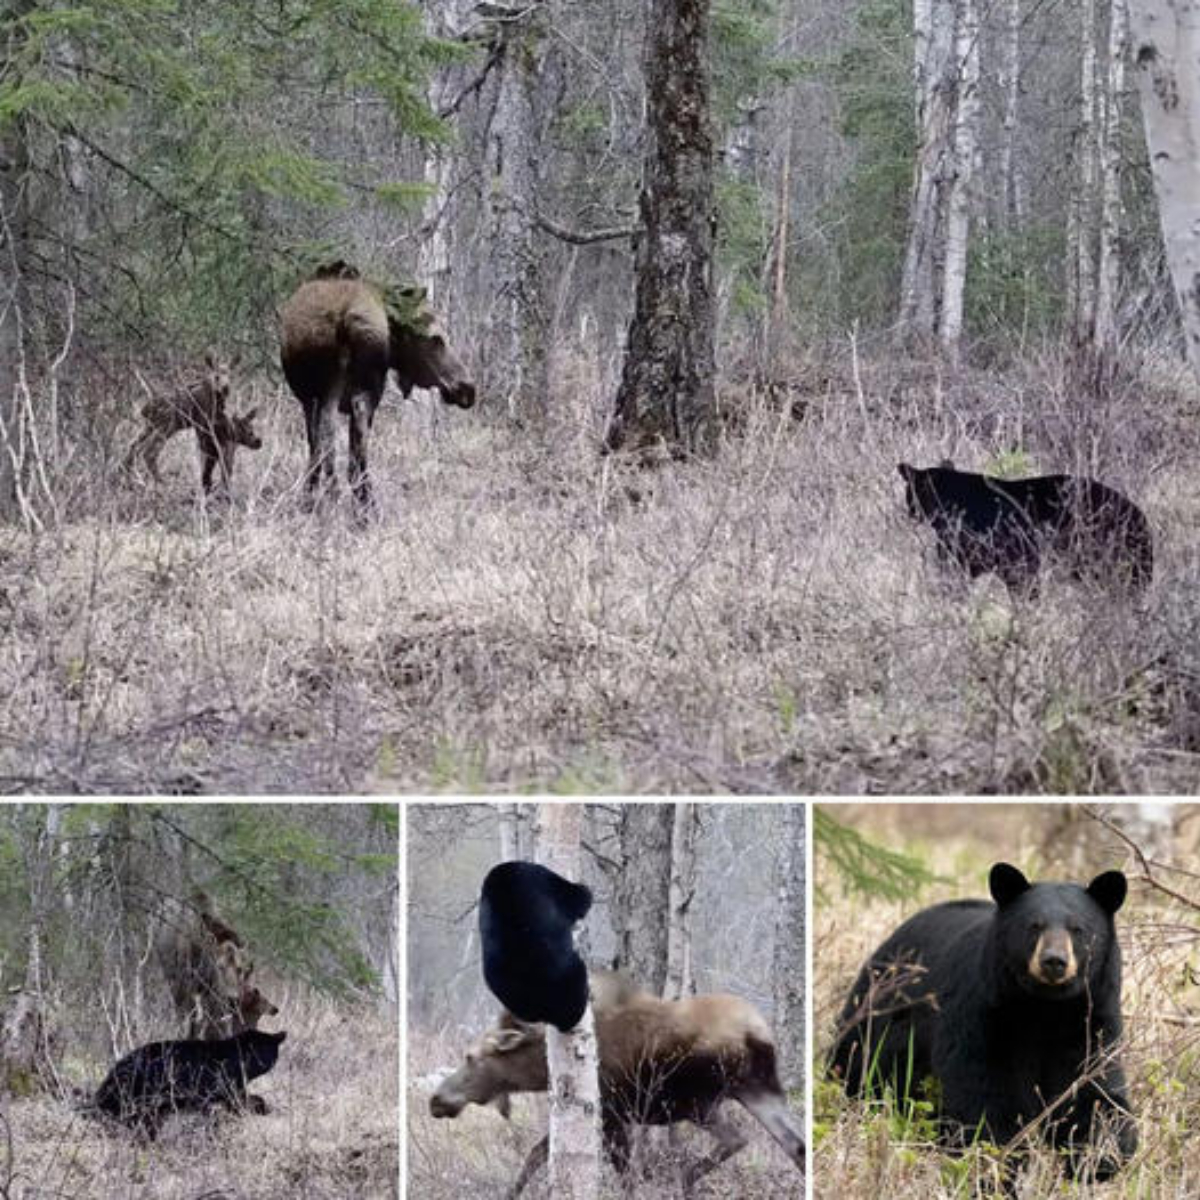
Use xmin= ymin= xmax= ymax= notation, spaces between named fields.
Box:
xmin=606 ymin=0 xmax=716 ymax=452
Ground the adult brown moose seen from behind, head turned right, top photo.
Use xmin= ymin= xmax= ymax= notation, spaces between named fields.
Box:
xmin=280 ymin=262 xmax=475 ymax=512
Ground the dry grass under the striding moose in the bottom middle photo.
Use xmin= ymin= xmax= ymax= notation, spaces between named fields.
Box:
xmin=406 ymin=1031 xmax=804 ymax=1200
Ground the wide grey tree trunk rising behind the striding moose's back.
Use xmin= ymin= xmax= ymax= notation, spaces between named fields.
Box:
xmin=612 ymin=804 xmax=674 ymax=996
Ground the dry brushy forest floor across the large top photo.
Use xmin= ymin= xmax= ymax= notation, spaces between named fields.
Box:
xmin=0 ymin=345 xmax=1200 ymax=793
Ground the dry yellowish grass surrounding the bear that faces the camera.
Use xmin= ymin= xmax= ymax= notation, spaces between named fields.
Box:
xmin=812 ymin=805 xmax=1200 ymax=1200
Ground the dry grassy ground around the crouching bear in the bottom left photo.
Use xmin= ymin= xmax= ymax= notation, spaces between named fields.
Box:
xmin=0 ymin=1001 xmax=400 ymax=1200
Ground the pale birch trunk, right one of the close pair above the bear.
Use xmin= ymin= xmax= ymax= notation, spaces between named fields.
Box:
xmin=937 ymin=0 xmax=979 ymax=355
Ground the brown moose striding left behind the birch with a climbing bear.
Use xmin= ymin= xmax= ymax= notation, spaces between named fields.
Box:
xmin=430 ymin=985 xmax=805 ymax=1200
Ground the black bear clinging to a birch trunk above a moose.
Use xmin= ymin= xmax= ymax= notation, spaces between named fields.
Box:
xmin=479 ymin=862 xmax=592 ymax=1033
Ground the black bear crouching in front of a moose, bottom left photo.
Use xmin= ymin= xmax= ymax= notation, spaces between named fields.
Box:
xmin=92 ymin=1030 xmax=287 ymax=1140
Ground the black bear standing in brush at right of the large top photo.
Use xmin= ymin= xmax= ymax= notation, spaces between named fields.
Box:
xmin=899 ymin=461 xmax=1154 ymax=594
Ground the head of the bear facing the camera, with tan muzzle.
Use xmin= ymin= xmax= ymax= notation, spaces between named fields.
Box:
xmin=988 ymin=863 xmax=1128 ymax=998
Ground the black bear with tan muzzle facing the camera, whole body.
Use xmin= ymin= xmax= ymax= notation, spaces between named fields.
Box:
xmin=829 ymin=863 xmax=1138 ymax=1180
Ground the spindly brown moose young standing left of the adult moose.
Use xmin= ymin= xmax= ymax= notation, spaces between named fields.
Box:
xmin=121 ymin=354 xmax=263 ymax=492
